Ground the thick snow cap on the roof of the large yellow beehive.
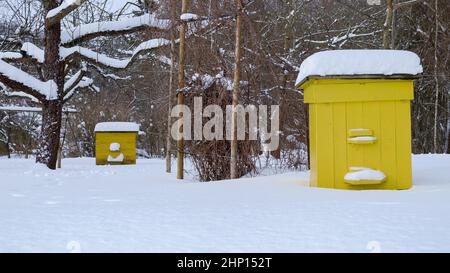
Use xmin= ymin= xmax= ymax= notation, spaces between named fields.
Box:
xmin=295 ymin=49 xmax=423 ymax=85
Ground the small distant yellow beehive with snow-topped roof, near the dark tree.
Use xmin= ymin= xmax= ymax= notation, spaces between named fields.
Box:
xmin=95 ymin=122 xmax=139 ymax=165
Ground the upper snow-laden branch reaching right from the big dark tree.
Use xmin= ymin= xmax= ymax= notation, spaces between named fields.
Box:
xmin=61 ymin=14 xmax=171 ymax=45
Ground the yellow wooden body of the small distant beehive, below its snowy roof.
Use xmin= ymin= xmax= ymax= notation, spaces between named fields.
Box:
xmin=95 ymin=132 xmax=137 ymax=165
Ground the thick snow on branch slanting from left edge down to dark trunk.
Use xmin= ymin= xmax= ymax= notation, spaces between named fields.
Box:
xmin=0 ymin=60 xmax=58 ymax=100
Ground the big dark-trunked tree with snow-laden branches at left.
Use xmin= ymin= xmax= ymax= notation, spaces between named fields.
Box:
xmin=0 ymin=0 xmax=170 ymax=169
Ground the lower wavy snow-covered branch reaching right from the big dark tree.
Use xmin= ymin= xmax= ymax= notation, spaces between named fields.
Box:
xmin=60 ymin=39 xmax=170 ymax=69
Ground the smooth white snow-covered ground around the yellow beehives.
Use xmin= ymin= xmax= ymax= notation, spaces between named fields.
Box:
xmin=0 ymin=155 xmax=450 ymax=252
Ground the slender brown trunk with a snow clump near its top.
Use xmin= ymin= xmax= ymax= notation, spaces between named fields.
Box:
xmin=177 ymin=0 xmax=189 ymax=179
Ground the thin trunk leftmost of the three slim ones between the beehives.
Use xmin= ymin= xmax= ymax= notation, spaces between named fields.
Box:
xmin=166 ymin=0 xmax=177 ymax=173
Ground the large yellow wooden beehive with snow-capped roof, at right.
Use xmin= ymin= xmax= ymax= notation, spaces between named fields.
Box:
xmin=297 ymin=50 xmax=422 ymax=190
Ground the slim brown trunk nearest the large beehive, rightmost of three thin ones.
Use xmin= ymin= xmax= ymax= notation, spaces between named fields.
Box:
xmin=230 ymin=0 xmax=242 ymax=179
